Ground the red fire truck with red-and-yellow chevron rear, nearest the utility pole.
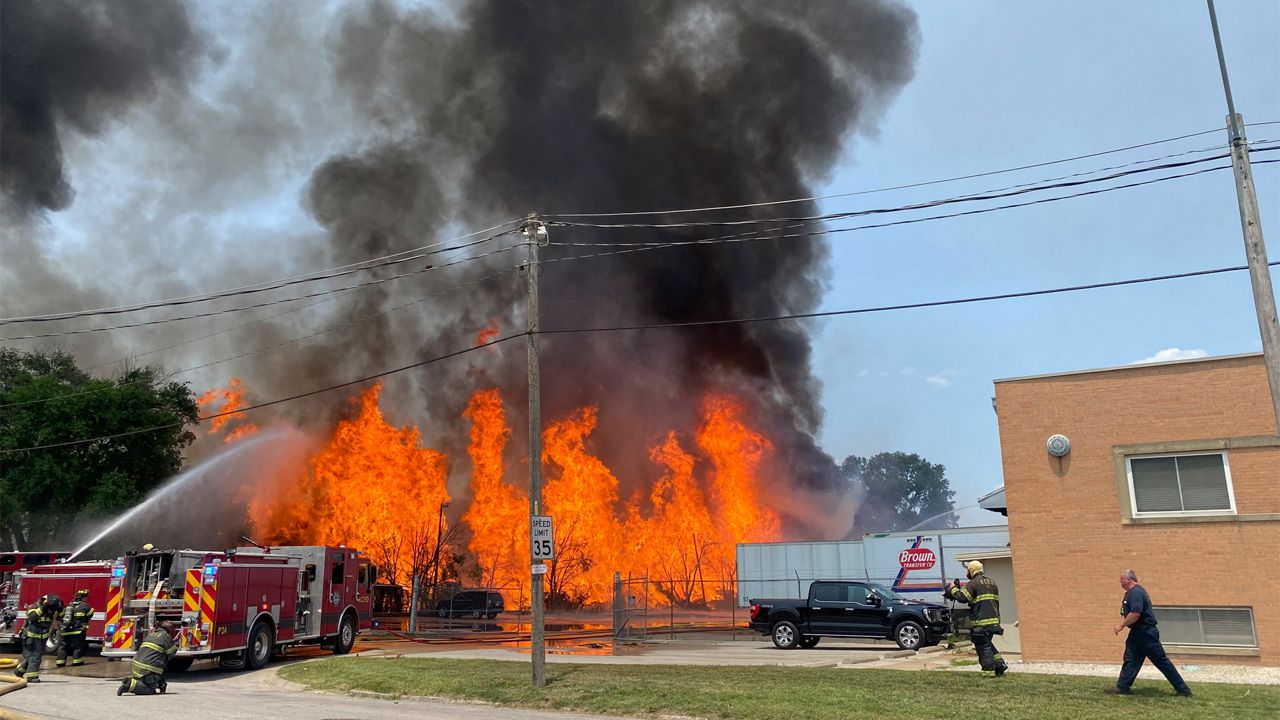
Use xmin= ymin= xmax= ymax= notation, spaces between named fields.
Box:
xmin=102 ymin=546 xmax=376 ymax=670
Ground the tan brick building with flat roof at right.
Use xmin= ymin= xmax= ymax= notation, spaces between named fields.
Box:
xmin=995 ymin=354 xmax=1280 ymax=666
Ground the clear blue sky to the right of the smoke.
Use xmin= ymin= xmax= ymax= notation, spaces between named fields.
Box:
xmin=815 ymin=0 xmax=1280 ymax=519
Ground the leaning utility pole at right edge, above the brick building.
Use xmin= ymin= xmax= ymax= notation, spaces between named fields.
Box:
xmin=1207 ymin=0 xmax=1280 ymax=432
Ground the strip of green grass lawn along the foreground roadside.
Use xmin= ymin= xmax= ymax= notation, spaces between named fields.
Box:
xmin=280 ymin=657 xmax=1280 ymax=720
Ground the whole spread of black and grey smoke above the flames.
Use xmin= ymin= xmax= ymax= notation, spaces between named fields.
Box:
xmin=0 ymin=0 xmax=918 ymax=535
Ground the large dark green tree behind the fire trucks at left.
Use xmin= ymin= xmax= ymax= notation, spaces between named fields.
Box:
xmin=0 ymin=348 xmax=198 ymax=550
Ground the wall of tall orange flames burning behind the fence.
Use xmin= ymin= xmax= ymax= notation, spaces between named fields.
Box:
xmin=250 ymin=386 xmax=782 ymax=605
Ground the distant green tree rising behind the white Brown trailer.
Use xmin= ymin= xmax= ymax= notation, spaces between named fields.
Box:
xmin=840 ymin=452 xmax=959 ymax=536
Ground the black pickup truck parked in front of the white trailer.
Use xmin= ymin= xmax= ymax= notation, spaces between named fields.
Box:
xmin=750 ymin=580 xmax=952 ymax=650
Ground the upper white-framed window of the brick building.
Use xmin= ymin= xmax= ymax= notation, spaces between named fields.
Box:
xmin=1128 ymin=452 xmax=1235 ymax=518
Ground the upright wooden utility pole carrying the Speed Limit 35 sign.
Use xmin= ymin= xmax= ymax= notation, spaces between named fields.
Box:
xmin=521 ymin=213 xmax=547 ymax=688
